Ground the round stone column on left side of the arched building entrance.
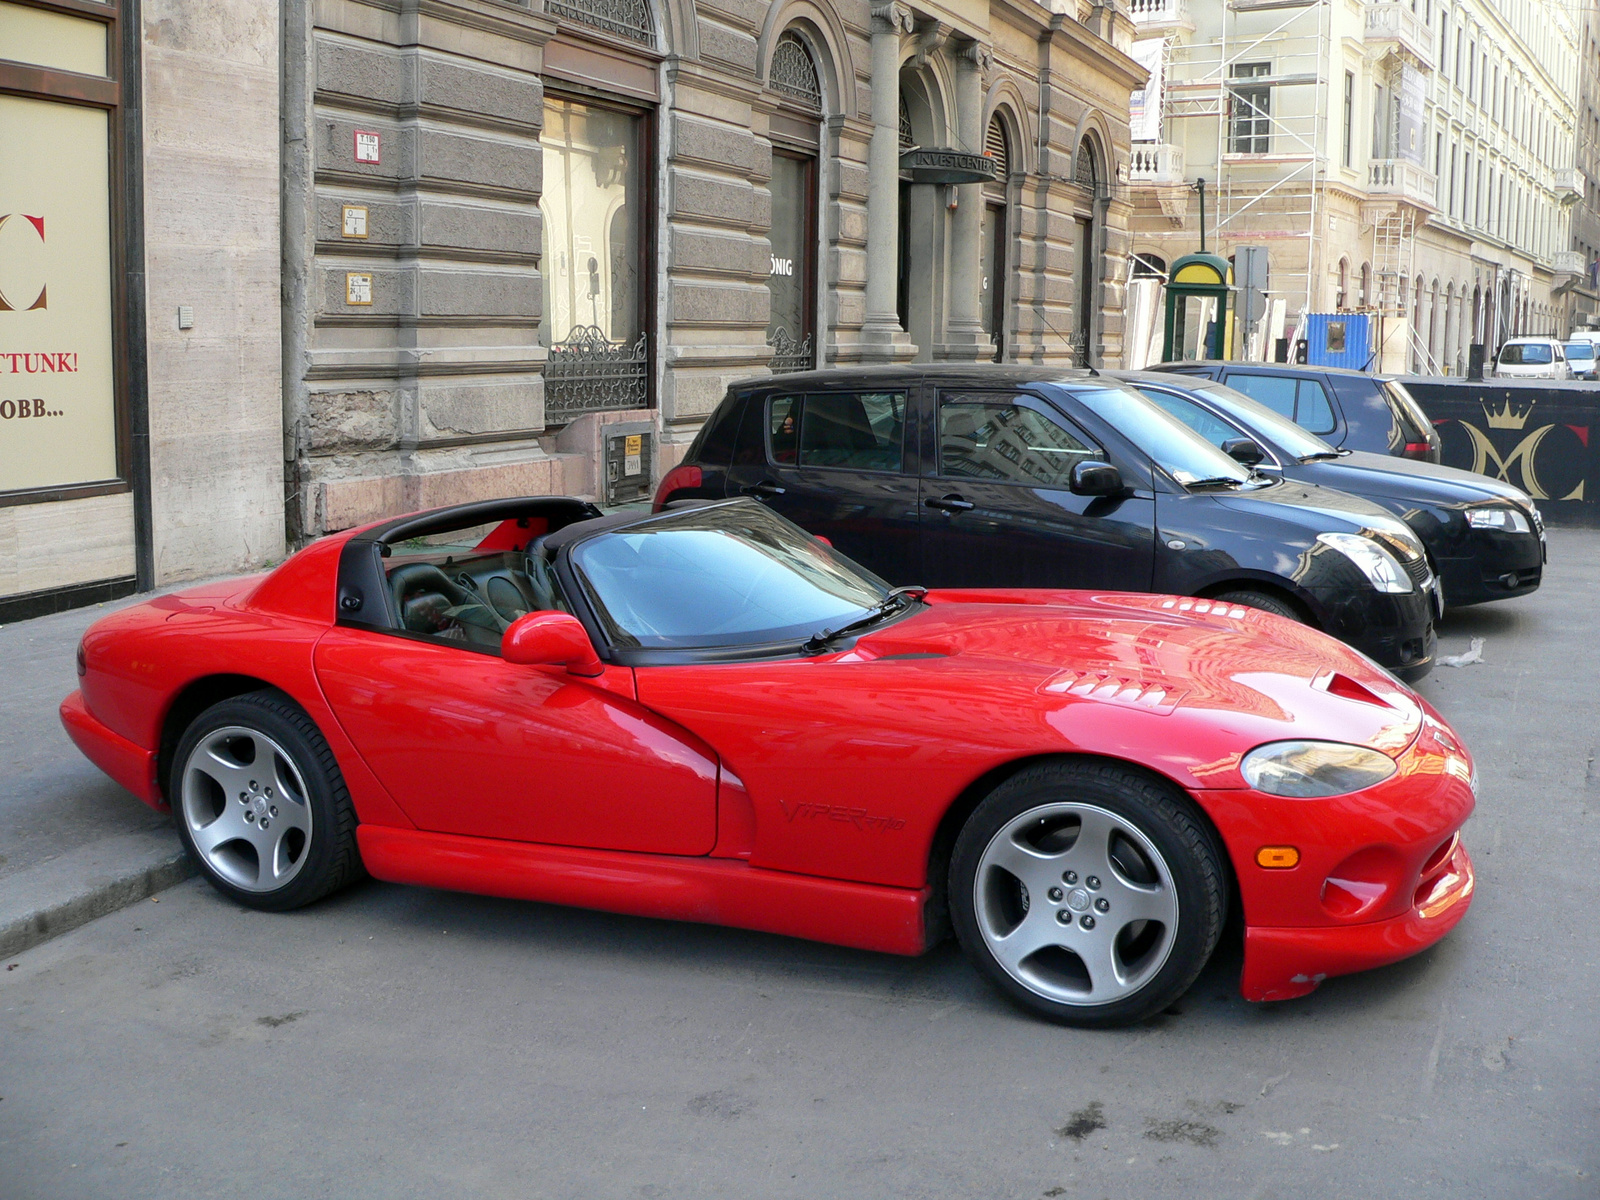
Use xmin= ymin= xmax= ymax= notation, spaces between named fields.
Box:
xmin=861 ymin=0 xmax=915 ymax=362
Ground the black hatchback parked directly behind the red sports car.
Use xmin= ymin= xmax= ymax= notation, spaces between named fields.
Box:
xmin=656 ymin=366 xmax=1437 ymax=678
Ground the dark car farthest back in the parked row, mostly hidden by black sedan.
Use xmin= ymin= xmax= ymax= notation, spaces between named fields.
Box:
xmin=1150 ymin=360 xmax=1442 ymax=462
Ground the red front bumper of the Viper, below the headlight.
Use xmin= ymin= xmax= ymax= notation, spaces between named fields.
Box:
xmin=1195 ymin=704 xmax=1475 ymax=1000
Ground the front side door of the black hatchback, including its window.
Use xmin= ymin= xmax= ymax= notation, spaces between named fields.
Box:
xmin=920 ymin=389 xmax=1155 ymax=592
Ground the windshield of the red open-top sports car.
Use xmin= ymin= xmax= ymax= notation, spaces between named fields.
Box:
xmin=571 ymin=501 xmax=888 ymax=650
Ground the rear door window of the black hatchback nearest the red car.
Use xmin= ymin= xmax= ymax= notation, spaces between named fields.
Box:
xmin=766 ymin=392 xmax=906 ymax=472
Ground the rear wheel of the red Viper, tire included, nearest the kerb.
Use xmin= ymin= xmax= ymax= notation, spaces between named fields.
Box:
xmin=166 ymin=691 xmax=365 ymax=912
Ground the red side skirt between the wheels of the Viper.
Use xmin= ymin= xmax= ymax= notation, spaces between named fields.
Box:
xmin=355 ymin=824 xmax=931 ymax=955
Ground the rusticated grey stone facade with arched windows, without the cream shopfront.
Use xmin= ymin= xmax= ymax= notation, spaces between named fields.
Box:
xmin=283 ymin=0 xmax=1142 ymax=539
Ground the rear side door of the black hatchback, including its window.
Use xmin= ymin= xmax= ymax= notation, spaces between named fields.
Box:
xmin=728 ymin=387 xmax=922 ymax=584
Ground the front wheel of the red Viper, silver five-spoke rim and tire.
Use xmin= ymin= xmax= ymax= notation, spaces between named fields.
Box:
xmin=949 ymin=760 xmax=1227 ymax=1026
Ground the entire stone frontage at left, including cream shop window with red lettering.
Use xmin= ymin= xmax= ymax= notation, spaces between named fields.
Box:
xmin=0 ymin=0 xmax=1144 ymax=621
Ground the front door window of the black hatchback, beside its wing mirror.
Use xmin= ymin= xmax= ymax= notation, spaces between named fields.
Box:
xmin=939 ymin=392 xmax=1102 ymax=488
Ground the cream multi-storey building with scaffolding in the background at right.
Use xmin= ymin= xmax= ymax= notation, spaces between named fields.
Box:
xmin=1133 ymin=0 xmax=1579 ymax=374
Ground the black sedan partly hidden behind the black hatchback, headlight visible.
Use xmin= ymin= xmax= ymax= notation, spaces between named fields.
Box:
xmin=1114 ymin=371 xmax=1546 ymax=605
